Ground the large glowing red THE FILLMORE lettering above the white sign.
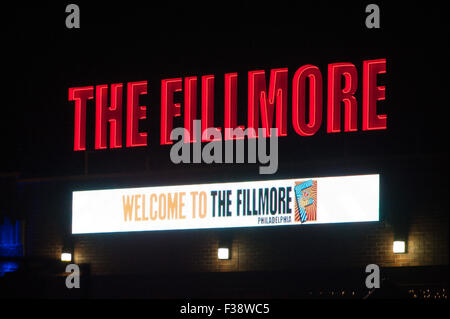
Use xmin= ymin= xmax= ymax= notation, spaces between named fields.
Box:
xmin=69 ymin=59 xmax=387 ymax=151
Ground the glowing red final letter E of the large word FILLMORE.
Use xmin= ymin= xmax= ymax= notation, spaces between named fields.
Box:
xmin=363 ymin=59 xmax=387 ymax=131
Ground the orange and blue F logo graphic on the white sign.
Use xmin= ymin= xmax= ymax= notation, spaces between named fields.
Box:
xmin=294 ymin=179 xmax=317 ymax=223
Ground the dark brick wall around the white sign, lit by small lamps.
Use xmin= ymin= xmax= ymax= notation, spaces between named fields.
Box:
xmin=23 ymin=158 xmax=449 ymax=275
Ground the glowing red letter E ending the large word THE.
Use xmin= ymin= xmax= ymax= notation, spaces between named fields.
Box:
xmin=127 ymin=81 xmax=147 ymax=147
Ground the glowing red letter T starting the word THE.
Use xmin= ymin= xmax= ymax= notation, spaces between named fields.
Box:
xmin=69 ymin=86 xmax=94 ymax=151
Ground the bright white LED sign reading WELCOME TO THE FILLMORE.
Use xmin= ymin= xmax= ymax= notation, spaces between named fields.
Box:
xmin=72 ymin=175 xmax=379 ymax=234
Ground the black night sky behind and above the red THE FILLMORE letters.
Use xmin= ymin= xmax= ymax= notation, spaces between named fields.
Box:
xmin=1 ymin=1 xmax=449 ymax=183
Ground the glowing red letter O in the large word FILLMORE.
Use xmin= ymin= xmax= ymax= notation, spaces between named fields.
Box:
xmin=292 ymin=65 xmax=322 ymax=136
